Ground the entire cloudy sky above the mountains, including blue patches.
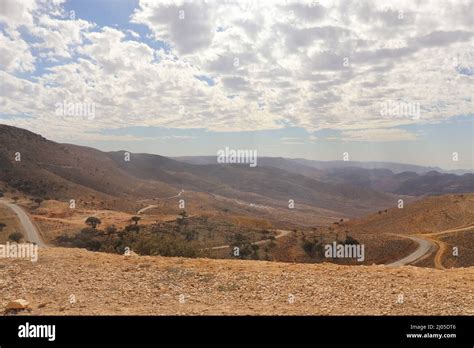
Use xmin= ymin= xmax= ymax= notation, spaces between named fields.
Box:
xmin=0 ymin=0 xmax=474 ymax=169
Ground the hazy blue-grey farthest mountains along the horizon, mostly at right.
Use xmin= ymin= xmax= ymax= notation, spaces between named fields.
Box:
xmin=175 ymin=156 xmax=474 ymax=196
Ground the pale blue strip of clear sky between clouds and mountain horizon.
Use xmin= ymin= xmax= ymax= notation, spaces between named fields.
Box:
xmin=83 ymin=116 xmax=473 ymax=169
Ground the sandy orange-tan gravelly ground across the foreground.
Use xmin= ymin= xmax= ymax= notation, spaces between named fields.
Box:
xmin=0 ymin=248 xmax=474 ymax=315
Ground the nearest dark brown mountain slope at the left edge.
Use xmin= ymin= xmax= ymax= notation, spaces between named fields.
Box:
xmin=0 ymin=125 xmax=175 ymax=208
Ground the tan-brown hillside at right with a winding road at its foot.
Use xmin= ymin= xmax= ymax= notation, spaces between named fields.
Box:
xmin=327 ymin=193 xmax=474 ymax=268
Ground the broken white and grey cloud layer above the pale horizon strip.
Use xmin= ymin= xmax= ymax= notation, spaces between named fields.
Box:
xmin=0 ymin=0 xmax=474 ymax=141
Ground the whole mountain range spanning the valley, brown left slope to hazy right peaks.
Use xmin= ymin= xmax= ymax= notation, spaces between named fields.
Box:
xmin=0 ymin=125 xmax=474 ymax=223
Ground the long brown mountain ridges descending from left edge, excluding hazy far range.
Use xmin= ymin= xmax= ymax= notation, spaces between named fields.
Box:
xmin=0 ymin=125 xmax=397 ymax=217
